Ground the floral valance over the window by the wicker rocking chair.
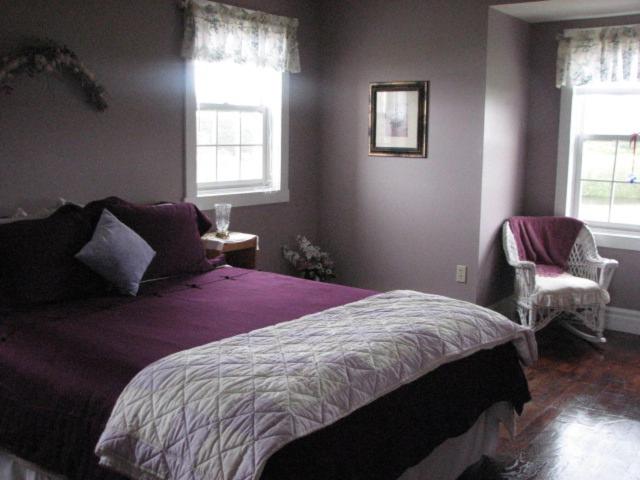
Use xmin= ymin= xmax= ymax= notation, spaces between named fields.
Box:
xmin=556 ymin=25 xmax=640 ymax=88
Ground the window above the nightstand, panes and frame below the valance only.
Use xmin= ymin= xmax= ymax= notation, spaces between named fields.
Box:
xmin=186 ymin=61 xmax=288 ymax=208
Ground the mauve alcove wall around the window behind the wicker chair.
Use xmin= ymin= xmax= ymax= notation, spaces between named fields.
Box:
xmin=525 ymin=15 xmax=640 ymax=310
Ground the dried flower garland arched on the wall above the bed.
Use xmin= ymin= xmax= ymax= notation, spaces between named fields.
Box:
xmin=0 ymin=40 xmax=107 ymax=111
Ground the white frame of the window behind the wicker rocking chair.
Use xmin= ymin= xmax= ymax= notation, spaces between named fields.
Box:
xmin=555 ymin=87 xmax=640 ymax=251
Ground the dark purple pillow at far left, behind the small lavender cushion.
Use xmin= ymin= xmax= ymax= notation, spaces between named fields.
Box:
xmin=0 ymin=204 xmax=106 ymax=305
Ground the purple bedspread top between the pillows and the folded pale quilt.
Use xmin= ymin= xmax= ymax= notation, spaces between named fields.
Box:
xmin=0 ymin=268 xmax=374 ymax=480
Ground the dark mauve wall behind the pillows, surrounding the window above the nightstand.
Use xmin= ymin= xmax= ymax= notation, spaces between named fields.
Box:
xmin=0 ymin=0 xmax=319 ymax=270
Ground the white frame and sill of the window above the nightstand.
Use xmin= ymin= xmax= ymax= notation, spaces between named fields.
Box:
xmin=184 ymin=60 xmax=289 ymax=210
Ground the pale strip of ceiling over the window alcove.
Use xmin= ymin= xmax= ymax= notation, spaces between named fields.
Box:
xmin=493 ymin=0 xmax=640 ymax=23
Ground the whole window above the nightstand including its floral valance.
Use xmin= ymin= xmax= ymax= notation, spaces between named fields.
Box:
xmin=181 ymin=0 xmax=300 ymax=209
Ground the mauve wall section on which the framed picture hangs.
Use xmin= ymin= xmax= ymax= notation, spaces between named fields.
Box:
xmin=320 ymin=0 xmax=500 ymax=300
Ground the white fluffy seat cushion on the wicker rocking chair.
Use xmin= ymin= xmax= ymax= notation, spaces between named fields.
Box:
xmin=533 ymin=273 xmax=609 ymax=307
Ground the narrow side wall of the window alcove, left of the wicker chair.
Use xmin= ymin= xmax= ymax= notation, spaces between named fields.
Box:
xmin=476 ymin=10 xmax=529 ymax=305
